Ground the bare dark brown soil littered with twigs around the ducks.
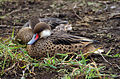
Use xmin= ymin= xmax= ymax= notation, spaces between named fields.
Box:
xmin=0 ymin=0 xmax=120 ymax=79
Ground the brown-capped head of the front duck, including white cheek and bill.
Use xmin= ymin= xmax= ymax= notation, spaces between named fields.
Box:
xmin=28 ymin=22 xmax=51 ymax=45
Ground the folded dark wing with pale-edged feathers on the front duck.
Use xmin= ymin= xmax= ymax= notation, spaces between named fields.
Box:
xmin=52 ymin=33 xmax=98 ymax=45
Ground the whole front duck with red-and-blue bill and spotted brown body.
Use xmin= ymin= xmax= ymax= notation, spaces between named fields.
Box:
xmin=26 ymin=23 xmax=101 ymax=57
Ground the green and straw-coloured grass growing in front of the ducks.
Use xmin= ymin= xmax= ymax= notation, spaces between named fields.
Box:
xmin=0 ymin=30 xmax=119 ymax=79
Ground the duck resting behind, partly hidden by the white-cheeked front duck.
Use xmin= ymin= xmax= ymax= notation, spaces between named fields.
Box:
xmin=15 ymin=16 xmax=72 ymax=44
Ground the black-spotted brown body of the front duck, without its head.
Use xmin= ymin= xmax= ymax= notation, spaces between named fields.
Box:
xmin=27 ymin=31 xmax=95 ymax=57
